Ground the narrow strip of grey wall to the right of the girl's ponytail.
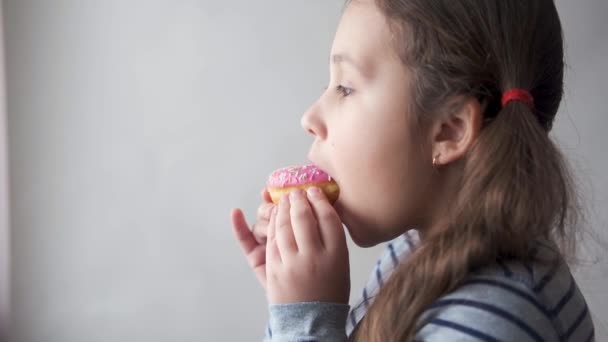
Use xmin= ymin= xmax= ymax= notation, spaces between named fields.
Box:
xmin=554 ymin=0 xmax=608 ymax=336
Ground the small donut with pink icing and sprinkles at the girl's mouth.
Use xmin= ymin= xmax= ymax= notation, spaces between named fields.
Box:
xmin=266 ymin=165 xmax=340 ymax=204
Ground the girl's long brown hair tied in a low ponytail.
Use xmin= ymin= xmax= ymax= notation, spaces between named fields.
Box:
xmin=352 ymin=0 xmax=580 ymax=341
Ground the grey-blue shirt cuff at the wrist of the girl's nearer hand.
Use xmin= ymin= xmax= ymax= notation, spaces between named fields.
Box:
xmin=264 ymin=302 xmax=350 ymax=342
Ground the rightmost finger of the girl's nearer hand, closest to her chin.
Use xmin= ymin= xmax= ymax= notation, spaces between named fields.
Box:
xmin=308 ymin=187 xmax=346 ymax=250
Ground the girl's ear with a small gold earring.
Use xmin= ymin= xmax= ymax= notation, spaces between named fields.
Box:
xmin=430 ymin=97 xmax=483 ymax=166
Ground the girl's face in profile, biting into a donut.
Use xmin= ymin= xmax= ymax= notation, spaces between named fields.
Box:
xmin=302 ymin=0 xmax=433 ymax=247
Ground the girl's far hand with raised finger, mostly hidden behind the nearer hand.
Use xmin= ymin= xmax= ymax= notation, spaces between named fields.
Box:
xmin=230 ymin=189 xmax=275 ymax=290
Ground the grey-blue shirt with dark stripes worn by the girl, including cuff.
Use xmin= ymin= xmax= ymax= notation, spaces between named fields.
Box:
xmin=265 ymin=230 xmax=595 ymax=342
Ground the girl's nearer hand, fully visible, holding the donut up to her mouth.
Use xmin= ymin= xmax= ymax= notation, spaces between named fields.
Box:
xmin=266 ymin=188 xmax=350 ymax=304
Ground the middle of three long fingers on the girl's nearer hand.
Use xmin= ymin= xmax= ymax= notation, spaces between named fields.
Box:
xmin=289 ymin=190 xmax=321 ymax=253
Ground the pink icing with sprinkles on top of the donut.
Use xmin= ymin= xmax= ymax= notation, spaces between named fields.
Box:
xmin=266 ymin=165 xmax=331 ymax=188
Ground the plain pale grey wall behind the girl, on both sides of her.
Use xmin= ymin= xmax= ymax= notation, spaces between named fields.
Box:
xmin=3 ymin=0 xmax=608 ymax=342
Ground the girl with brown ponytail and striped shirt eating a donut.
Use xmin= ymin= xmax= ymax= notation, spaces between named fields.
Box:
xmin=232 ymin=0 xmax=594 ymax=341
